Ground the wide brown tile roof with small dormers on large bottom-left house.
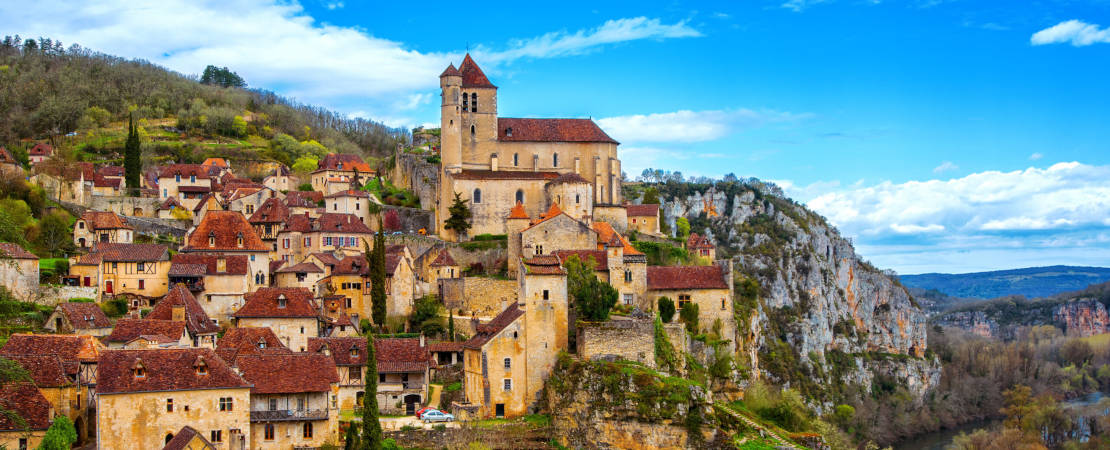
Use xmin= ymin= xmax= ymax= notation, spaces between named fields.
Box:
xmin=97 ymin=349 xmax=251 ymax=393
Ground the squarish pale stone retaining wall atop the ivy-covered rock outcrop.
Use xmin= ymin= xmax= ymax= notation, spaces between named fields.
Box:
xmin=577 ymin=318 xmax=655 ymax=368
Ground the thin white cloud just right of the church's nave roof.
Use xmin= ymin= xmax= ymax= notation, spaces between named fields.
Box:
xmin=597 ymin=109 xmax=810 ymax=142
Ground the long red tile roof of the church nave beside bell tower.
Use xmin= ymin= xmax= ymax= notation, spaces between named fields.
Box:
xmin=497 ymin=117 xmax=619 ymax=143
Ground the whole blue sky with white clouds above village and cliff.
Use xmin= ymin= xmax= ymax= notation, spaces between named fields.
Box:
xmin=0 ymin=0 xmax=1110 ymax=273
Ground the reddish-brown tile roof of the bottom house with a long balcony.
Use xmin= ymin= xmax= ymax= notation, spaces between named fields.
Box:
xmin=235 ymin=352 xmax=340 ymax=393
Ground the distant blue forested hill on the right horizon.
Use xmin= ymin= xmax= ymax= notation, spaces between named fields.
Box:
xmin=899 ymin=266 xmax=1110 ymax=299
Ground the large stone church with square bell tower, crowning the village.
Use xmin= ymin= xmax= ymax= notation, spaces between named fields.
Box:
xmin=435 ymin=54 xmax=625 ymax=240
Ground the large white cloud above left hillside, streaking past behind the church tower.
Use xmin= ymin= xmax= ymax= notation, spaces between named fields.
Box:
xmin=0 ymin=0 xmax=700 ymax=124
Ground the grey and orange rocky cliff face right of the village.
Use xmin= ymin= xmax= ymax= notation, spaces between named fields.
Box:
xmin=659 ymin=181 xmax=939 ymax=397
